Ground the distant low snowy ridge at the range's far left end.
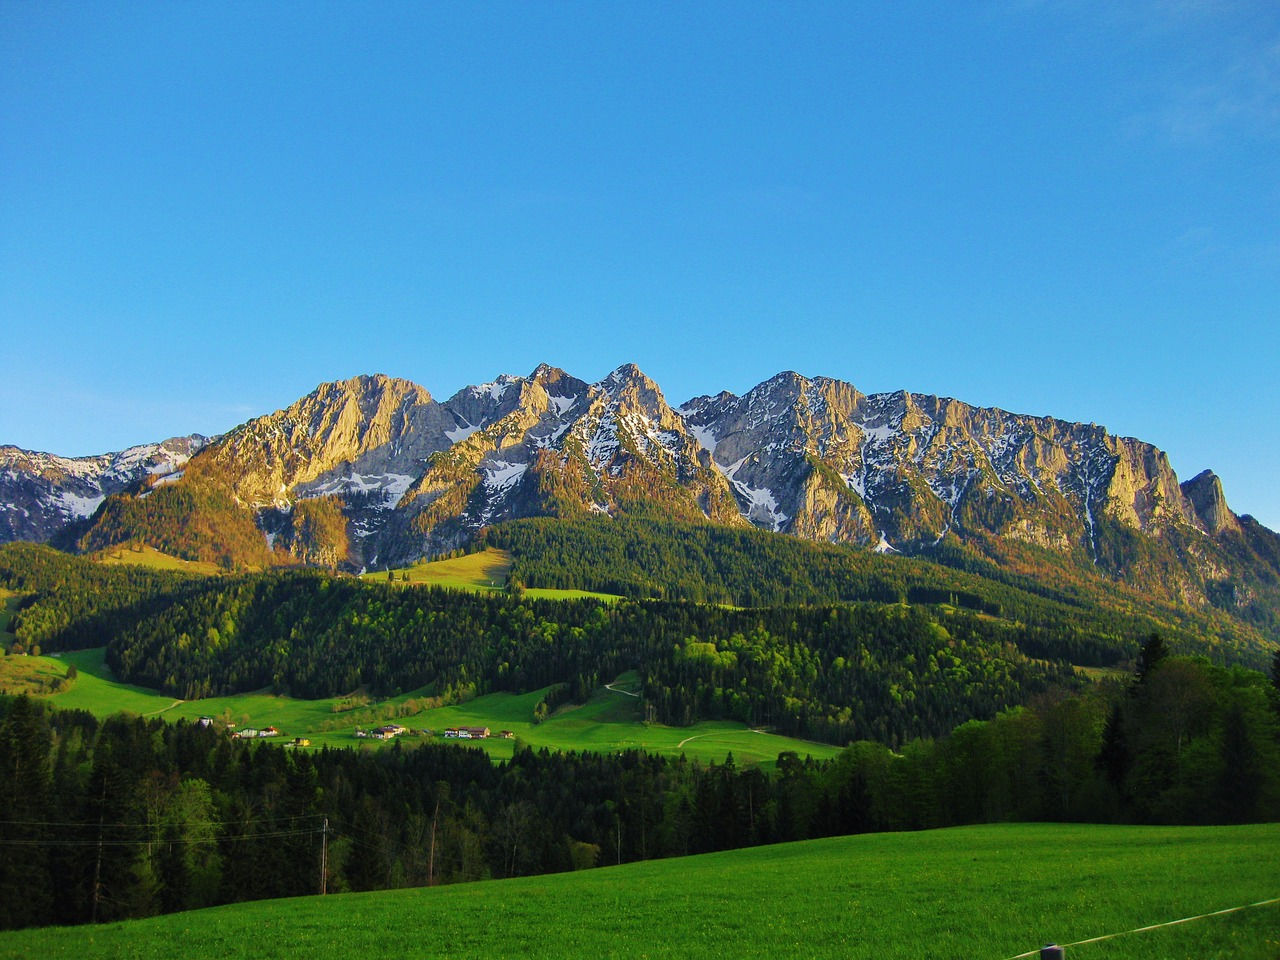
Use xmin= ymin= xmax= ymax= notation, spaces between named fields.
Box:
xmin=0 ymin=434 xmax=207 ymax=543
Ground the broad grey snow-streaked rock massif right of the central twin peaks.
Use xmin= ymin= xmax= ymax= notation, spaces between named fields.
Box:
xmin=681 ymin=372 xmax=1234 ymax=557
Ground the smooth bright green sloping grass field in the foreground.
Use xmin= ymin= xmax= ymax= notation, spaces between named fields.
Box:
xmin=0 ymin=824 xmax=1280 ymax=960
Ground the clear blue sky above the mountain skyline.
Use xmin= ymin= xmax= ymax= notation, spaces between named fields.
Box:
xmin=0 ymin=0 xmax=1280 ymax=529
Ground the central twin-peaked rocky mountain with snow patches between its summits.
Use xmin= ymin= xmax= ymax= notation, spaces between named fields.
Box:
xmin=379 ymin=365 xmax=741 ymax=558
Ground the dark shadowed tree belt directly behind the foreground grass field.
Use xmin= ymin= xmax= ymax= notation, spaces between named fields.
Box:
xmin=0 ymin=639 xmax=1280 ymax=927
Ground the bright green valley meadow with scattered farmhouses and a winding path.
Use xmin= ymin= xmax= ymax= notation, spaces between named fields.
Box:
xmin=24 ymin=648 xmax=840 ymax=764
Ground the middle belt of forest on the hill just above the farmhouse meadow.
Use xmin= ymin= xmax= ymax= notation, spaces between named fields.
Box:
xmin=15 ymin=555 xmax=1078 ymax=744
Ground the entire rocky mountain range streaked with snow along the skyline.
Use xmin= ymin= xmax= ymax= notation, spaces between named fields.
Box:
xmin=0 ymin=364 xmax=1280 ymax=634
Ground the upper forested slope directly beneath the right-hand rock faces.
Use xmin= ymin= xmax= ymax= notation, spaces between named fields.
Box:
xmin=479 ymin=517 xmax=1274 ymax=668
